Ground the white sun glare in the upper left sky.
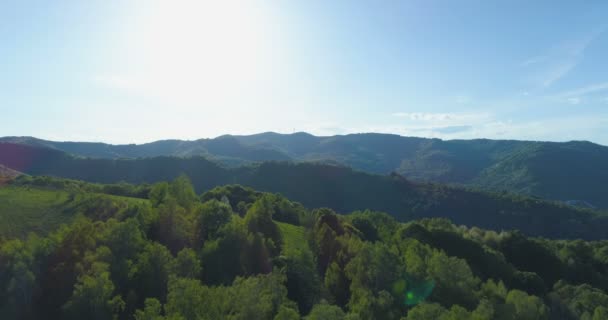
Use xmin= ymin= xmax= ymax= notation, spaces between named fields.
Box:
xmin=113 ymin=0 xmax=274 ymax=106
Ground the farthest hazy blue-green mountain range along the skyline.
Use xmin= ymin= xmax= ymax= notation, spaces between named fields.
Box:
xmin=0 ymin=133 xmax=608 ymax=208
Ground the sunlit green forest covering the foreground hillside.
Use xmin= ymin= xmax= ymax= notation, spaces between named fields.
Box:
xmin=0 ymin=176 xmax=608 ymax=320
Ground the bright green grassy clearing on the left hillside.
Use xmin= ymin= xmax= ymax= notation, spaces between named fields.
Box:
xmin=0 ymin=186 xmax=146 ymax=238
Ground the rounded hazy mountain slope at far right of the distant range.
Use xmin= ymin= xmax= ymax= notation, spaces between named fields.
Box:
xmin=475 ymin=141 xmax=608 ymax=202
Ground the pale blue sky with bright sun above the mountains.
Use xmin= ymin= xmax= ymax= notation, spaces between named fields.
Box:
xmin=0 ymin=0 xmax=608 ymax=145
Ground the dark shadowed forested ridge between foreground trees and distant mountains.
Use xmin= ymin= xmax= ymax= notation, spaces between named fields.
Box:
xmin=0 ymin=144 xmax=608 ymax=239
